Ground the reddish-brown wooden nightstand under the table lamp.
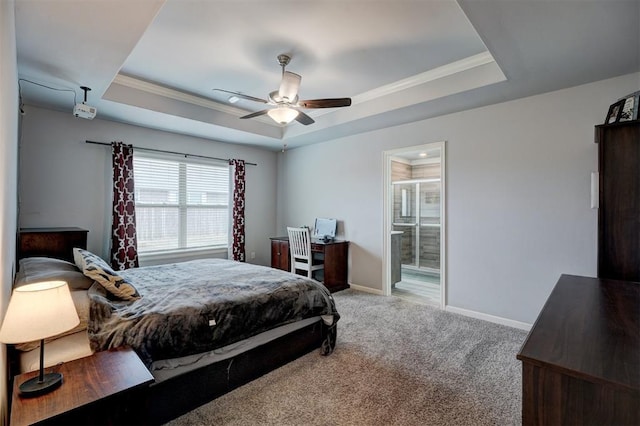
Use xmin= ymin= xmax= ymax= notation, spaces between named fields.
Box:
xmin=10 ymin=349 xmax=153 ymax=426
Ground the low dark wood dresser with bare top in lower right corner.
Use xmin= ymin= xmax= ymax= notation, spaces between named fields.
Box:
xmin=517 ymin=275 xmax=640 ymax=425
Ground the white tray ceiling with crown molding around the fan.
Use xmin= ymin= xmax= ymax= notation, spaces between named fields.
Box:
xmin=16 ymin=0 xmax=640 ymax=150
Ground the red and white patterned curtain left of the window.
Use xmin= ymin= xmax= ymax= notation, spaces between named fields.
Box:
xmin=111 ymin=142 xmax=138 ymax=271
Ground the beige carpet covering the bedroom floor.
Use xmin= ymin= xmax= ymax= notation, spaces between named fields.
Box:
xmin=169 ymin=290 xmax=526 ymax=425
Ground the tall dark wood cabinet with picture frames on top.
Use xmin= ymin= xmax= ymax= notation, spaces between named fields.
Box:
xmin=595 ymin=121 xmax=640 ymax=281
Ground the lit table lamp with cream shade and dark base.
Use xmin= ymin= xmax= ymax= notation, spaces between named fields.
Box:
xmin=0 ymin=281 xmax=80 ymax=396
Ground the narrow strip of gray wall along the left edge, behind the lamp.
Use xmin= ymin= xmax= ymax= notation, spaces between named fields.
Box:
xmin=0 ymin=0 xmax=18 ymax=424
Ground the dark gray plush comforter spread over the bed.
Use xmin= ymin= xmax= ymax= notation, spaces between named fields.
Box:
xmin=88 ymin=259 xmax=340 ymax=365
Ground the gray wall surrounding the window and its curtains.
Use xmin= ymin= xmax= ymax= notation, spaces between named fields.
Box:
xmin=19 ymin=106 xmax=277 ymax=265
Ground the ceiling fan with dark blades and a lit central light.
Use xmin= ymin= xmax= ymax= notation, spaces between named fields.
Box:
xmin=213 ymin=54 xmax=351 ymax=126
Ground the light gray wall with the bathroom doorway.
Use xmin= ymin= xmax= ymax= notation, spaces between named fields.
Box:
xmin=278 ymin=74 xmax=639 ymax=323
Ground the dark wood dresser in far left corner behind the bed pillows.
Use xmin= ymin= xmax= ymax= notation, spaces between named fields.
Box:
xmin=18 ymin=227 xmax=89 ymax=263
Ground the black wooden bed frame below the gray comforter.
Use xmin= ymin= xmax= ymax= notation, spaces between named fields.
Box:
xmin=8 ymin=246 xmax=337 ymax=424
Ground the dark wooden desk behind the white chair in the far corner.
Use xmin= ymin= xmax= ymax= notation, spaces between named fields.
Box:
xmin=271 ymin=237 xmax=349 ymax=293
